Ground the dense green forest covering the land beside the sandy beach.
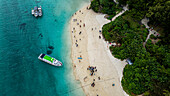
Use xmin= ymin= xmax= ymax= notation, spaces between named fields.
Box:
xmin=91 ymin=0 xmax=170 ymax=96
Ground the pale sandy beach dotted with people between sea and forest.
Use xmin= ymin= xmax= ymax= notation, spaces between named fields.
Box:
xmin=69 ymin=5 xmax=126 ymax=96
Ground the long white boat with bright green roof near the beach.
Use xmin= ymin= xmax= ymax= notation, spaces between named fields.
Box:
xmin=38 ymin=53 xmax=63 ymax=66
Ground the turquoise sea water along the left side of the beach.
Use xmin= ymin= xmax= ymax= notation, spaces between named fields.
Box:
xmin=0 ymin=0 xmax=89 ymax=96
